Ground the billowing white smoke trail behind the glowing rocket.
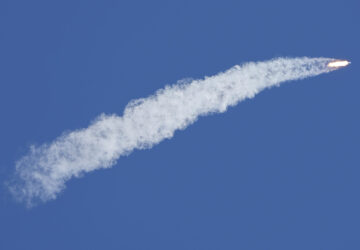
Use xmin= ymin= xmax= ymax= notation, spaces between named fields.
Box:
xmin=9 ymin=57 xmax=333 ymax=206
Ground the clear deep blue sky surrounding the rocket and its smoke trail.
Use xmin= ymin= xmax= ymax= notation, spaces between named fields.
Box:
xmin=0 ymin=0 xmax=360 ymax=250
